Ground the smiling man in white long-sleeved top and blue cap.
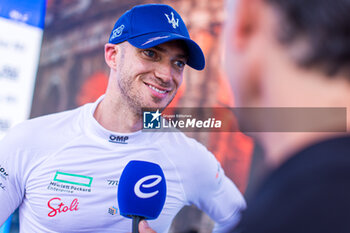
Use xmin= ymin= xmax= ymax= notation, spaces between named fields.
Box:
xmin=0 ymin=4 xmax=245 ymax=233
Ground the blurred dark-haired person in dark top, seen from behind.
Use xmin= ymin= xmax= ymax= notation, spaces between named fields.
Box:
xmin=224 ymin=0 xmax=350 ymax=233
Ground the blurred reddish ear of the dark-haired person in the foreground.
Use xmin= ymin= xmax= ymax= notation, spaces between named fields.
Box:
xmin=230 ymin=0 xmax=263 ymax=50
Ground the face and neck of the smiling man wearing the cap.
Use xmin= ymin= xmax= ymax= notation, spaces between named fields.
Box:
xmin=95 ymin=40 xmax=188 ymax=129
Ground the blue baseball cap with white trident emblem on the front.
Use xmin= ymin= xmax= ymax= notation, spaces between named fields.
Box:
xmin=109 ymin=4 xmax=205 ymax=70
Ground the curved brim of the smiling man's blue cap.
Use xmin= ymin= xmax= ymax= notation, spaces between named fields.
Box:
xmin=127 ymin=32 xmax=205 ymax=70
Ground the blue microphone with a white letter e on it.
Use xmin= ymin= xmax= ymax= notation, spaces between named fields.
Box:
xmin=118 ymin=160 xmax=166 ymax=233
